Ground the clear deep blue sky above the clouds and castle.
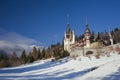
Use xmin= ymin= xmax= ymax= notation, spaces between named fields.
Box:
xmin=0 ymin=0 xmax=120 ymax=46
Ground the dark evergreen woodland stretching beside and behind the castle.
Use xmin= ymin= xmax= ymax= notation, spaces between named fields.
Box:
xmin=0 ymin=28 xmax=120 ymax=67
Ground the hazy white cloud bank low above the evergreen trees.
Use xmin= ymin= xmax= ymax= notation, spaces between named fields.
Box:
xmin=0 ymin=28 xmax=42 ymax=56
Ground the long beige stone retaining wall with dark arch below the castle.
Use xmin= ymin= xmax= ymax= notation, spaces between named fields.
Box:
xmin=70 ymin=43 xmax=120 ymax=56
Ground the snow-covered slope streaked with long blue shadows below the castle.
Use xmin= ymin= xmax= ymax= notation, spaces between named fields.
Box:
xmin=0 ymin=52 xmax=120 ymax=80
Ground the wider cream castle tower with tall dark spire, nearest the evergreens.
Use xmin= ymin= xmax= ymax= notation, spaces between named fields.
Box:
xmin=64 ymin=16 xmax=75 ymax=52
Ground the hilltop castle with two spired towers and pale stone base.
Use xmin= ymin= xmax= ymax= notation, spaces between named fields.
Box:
xmin=64 ymin=16 xmax=113 ymax=55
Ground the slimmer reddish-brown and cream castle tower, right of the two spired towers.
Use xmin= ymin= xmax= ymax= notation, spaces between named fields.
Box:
xmin=84 ymin=20 xmax=90 ymax=48
